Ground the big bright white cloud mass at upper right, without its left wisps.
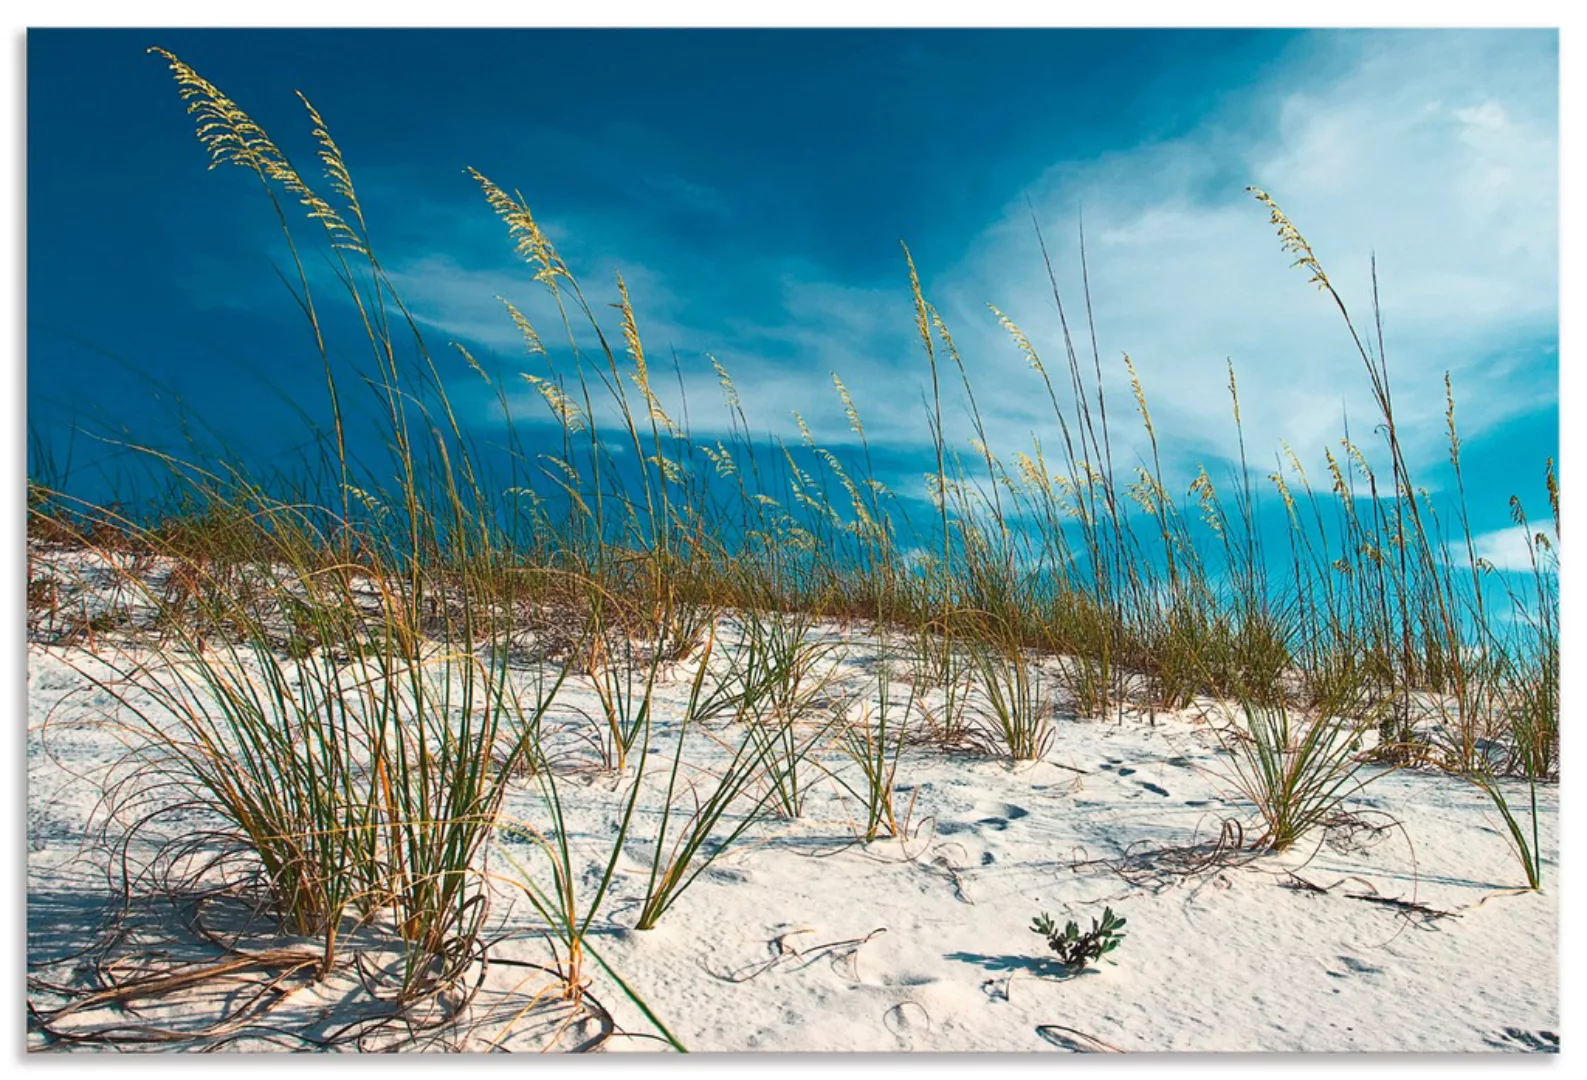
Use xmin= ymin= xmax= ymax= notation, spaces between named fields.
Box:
xmin=940 ymin=33 xmax=1557 ymax=478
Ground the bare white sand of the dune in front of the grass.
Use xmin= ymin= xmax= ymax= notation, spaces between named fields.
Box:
xmin=29 ymin=567 xmax=1558 ymax=1051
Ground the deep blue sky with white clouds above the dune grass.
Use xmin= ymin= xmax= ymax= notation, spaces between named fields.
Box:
xmin=27 ymin=30 xmax=1558 ymax=561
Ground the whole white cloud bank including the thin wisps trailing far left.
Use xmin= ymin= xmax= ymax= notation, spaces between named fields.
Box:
xmin=390 ymin=32 xmax=1557 ymax=494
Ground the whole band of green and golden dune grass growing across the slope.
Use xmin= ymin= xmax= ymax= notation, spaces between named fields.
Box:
xmin=29 ymin=51 xmax=1558 ymax=1046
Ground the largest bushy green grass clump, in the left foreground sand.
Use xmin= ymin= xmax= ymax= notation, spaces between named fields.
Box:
xmin=49 ymin=493 xmax=560 ymax=1001
